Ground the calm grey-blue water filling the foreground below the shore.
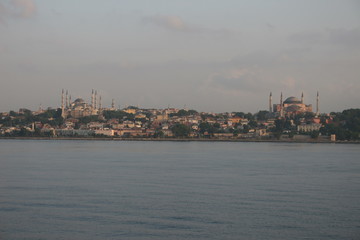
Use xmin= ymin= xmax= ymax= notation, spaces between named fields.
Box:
xmin=0 ymin=140 xmax=360 ymax=240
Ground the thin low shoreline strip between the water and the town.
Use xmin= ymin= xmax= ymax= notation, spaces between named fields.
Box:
xmin=0 ymin=137 xmax=360 ymax=144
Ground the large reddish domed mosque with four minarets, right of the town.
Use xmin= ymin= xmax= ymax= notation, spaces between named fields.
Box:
xmin=269 ymin=92 xmax=319 ymax=117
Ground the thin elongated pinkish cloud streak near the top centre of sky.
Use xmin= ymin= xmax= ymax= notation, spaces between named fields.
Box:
xmin=142 ymin=15 xmax=232 ymax=34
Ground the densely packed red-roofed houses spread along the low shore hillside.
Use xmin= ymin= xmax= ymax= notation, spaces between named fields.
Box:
xmin=0 ymin=108 xmax=322 ymax=138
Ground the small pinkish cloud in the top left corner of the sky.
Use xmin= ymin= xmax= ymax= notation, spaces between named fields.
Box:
xmin=0 ymin=0 xmax=36 ymax=23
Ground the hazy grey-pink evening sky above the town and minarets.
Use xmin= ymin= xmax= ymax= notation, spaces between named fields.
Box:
xmin=0 ymin=0 xmax=360 ymax=113
